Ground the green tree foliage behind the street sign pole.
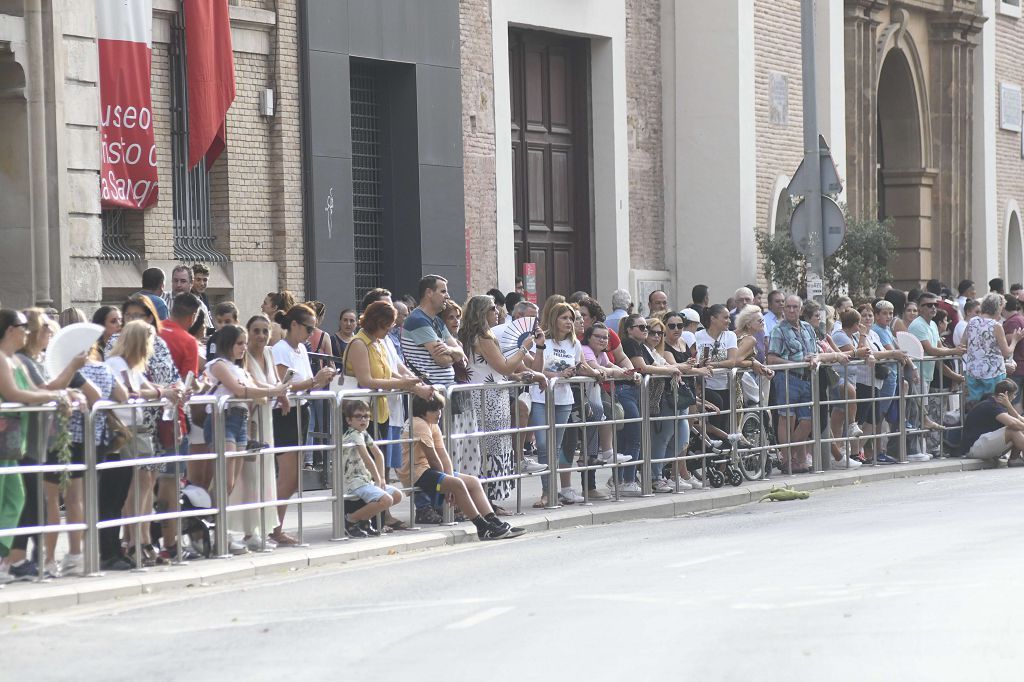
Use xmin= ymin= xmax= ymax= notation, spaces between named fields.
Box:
xmin=755 ymin=200 xmax=897 ymax=299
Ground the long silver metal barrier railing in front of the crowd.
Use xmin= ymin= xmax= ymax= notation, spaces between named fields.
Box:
xmin=0 ymin=350 xmax=965 ymax=580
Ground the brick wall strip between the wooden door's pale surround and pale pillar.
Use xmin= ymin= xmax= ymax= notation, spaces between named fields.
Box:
xmin=626 ymin=0 xmax=665 ymax=270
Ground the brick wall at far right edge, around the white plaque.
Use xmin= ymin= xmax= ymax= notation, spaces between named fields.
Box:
xmin=991 ymin=14 xmax=1024 ymax=278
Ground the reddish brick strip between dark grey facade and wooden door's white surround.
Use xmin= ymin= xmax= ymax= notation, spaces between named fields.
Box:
xmin=459 ymin=0 xmax=498 ymax=292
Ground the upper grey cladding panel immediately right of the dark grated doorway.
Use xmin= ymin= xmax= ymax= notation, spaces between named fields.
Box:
xmin=416 ymin=65 xmax=462 ymax=168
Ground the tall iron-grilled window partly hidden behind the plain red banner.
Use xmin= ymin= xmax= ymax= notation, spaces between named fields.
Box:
xmin=170 ymin=13 xmax=227 ymax=262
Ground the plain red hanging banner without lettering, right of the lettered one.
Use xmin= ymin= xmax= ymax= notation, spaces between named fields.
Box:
xmin=183 ymin=0 xmax=234 ymax=169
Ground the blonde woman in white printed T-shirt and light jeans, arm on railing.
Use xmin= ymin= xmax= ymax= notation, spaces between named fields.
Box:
xmin=529 ymin=302 xmax=601 ymax=507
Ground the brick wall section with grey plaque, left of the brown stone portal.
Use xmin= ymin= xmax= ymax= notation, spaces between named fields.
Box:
xmin=749 ymin=0 xmax=804 ymax=286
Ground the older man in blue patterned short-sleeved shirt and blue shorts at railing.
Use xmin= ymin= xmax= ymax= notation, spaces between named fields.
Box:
xmin=766 ymin=296 xmax=818 ymax=473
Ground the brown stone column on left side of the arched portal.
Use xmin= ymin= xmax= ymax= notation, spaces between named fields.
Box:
xmin=845 ymin=0 xmax=889 ymax=217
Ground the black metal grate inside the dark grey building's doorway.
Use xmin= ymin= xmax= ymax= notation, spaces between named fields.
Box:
xmin=351 ymin=61 xmax=386 ymax=300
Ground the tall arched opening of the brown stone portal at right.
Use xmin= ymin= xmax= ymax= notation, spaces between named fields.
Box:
xmin=877 ymin=48 xmax=935 ymax=288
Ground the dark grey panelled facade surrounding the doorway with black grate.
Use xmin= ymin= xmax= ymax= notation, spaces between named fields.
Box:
xmin=300 ymin=0 xmax=466 ymax=305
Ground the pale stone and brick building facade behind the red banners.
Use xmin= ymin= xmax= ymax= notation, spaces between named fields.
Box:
xmin=0 ymin=0 xmax=304 ymax=313
